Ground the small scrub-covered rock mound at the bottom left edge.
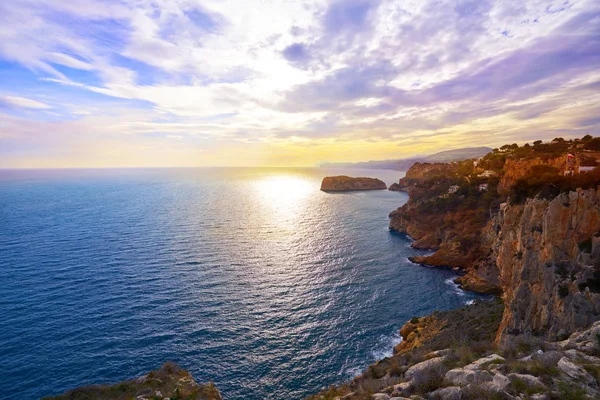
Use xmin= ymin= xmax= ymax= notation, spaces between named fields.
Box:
xmin=45 ymin=362 xmax=223 ymax=400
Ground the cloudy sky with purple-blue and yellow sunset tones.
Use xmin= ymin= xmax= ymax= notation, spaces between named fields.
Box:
xmin=0 ymin=0 xmax=600 ymax=168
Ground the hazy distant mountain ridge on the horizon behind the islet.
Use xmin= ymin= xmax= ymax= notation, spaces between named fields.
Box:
xmin=320 ymin=147 xmax=492 ymax=171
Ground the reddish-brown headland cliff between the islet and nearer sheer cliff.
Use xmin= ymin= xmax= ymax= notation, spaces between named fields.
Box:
xmin=389 ymin=163 xmax=500 ymax=293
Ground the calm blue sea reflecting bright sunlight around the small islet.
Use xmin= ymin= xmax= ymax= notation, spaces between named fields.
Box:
xmin=0 ymin=169 xmax=482 ymax=400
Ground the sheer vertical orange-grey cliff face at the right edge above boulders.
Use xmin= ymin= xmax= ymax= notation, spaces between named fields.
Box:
xmin=488 ymin=189 xmax=600 ymax=343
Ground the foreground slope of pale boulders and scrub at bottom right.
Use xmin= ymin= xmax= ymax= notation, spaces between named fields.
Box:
xmin=307 ymin=299 xmax=600 ymax=400
